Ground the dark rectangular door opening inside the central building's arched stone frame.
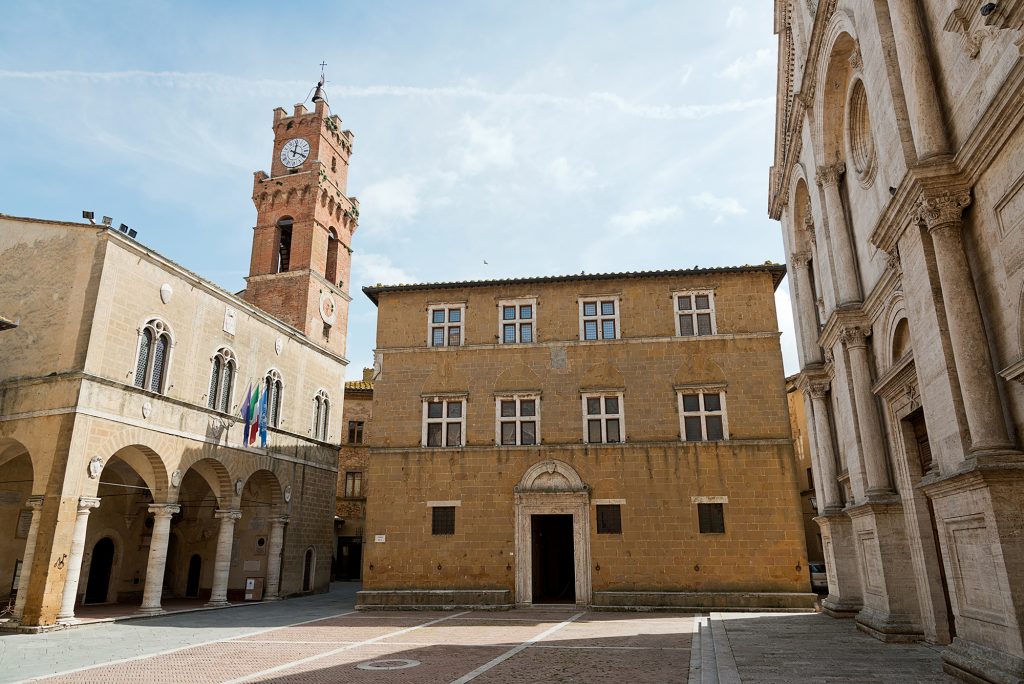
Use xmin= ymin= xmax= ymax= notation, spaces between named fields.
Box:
xmin=530 ymin=515 xmax=575 ymax=603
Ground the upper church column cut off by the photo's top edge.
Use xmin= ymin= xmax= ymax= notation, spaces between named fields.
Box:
xmin=888 ymin=0 xmax=946 ymax=160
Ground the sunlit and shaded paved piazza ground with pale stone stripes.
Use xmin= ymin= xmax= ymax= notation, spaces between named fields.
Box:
xmin=0 ymin=585 xmax=953 ymax=684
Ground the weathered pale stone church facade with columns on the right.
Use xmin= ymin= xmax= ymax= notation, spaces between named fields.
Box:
xmin=769 ymin=0 xmax=1024 ymax=682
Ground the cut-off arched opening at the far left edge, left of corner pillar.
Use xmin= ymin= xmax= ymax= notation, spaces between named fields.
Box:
xmin=0 ymin=438 xmax=36 ymax=602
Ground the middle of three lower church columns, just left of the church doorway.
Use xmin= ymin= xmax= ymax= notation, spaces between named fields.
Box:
xmin=842 ymin=327 xmax=893 ymax=497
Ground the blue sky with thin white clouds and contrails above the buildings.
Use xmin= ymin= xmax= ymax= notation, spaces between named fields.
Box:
xmin=0 ymin=0 xmax=798 ymax=378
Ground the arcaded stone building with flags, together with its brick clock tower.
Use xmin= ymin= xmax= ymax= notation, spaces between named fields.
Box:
xmin=0 ymin=97 xmax=358 ymax=629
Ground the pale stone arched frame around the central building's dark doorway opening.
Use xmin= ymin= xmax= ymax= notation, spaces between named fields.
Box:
xmin=515 ymin=459 xmax=592 ymax=605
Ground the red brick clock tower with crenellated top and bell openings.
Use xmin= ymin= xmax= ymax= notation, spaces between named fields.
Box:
xmin=245 ymin=80 xmax=359 ymax=355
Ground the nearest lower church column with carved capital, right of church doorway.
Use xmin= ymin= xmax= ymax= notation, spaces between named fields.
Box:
xmin=921 ymin=191 xmax=1013 ymax=454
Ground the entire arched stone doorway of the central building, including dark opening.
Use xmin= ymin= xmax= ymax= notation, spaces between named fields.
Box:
xmin=515 ymin=460 xmax=591 ymax=605
